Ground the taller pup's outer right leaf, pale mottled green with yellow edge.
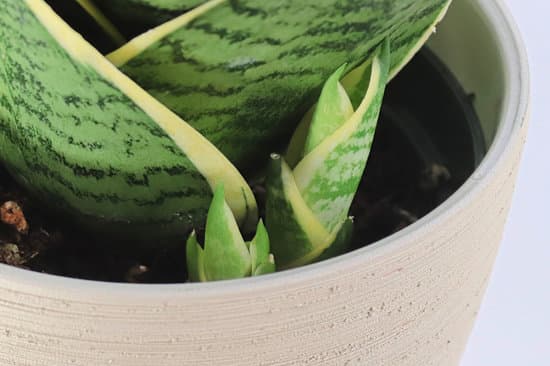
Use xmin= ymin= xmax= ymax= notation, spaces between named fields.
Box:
xmin=294 ymin=43 xmax=390 ymax=231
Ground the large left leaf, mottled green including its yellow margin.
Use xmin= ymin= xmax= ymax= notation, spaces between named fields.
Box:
xmin=0 ymin=0 xmax=257 ymax=243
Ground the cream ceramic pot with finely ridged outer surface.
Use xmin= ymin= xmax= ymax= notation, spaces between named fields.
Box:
xmin=0 ymin=0 xmax=529 ymax=366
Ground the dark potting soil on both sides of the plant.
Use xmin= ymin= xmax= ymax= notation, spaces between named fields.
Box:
xmin=0 ymin=51 xmax=484 ymax=283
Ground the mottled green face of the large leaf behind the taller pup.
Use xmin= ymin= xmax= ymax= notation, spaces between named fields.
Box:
xmin=122 ymin=0 xmax=448 ymax=172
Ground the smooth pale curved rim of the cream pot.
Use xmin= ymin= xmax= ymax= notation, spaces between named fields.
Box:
xmin=0 ymin=0 xmax=530 ymax=301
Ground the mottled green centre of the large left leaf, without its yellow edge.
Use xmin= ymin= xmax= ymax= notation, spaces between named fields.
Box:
xmin=0 ymin=0 xmax=212 ymax=242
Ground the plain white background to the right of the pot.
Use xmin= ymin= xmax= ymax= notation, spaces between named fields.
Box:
xmin=462 ymin=0 xmax=550 ymax=366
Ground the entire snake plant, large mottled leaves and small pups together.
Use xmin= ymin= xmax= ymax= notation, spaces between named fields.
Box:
xmin=0 ymin=0 xmax=450 ymax=280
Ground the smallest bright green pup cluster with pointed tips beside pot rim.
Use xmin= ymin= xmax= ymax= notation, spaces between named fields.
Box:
xmin=187 ymin=185 xmax=275 ymax=282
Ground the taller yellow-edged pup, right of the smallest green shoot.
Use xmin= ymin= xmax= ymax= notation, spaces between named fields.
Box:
xmin=266 ymin=41 xmax=390 ymax=268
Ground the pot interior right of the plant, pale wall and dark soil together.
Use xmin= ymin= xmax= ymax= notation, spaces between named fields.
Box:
xmin=353 ymin=0 xmax=519 ymax=248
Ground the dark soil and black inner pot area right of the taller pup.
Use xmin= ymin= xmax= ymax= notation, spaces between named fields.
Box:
xmin=352 ymin=49 xmax=486 ymax=248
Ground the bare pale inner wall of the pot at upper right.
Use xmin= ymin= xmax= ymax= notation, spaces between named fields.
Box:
xmin=428 ymin=0 xmax=513 ymax=146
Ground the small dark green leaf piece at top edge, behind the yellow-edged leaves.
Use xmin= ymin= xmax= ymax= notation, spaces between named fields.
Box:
xmin=95 ymin=0 xmax=207 ymax=26
